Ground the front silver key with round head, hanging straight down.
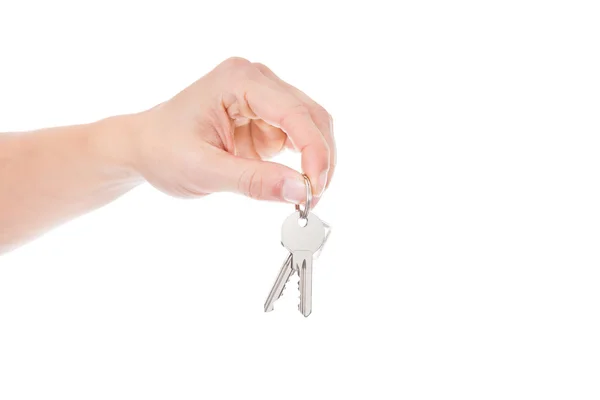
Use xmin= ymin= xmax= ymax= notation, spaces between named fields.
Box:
xmin=281 ymin=212 xmax=327 ymax=317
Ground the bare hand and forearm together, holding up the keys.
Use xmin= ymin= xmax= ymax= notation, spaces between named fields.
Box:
xmin=0 ymin=58 xmax=336 ymax=254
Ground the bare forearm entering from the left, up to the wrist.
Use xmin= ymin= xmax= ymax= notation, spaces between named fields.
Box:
xmin=0 ymin=116 xmax=142 ymax=254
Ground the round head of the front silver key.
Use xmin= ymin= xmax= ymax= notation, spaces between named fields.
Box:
xmin=281 ymin=212 xmax=326 ymax=254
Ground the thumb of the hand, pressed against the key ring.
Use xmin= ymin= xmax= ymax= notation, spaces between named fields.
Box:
xmin=206 ymin=151 xmax=306 ymax=204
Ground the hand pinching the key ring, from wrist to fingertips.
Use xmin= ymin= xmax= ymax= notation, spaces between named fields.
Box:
xmin=129 ymin=58 xmax=336 ymax=203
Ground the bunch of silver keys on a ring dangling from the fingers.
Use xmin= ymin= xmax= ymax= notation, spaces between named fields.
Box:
xmin=265 ymin=175 xmax=331 ymax=317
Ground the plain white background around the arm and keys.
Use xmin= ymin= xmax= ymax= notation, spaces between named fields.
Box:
xmin=0 ymin=0 xmax=600 ymax=400
